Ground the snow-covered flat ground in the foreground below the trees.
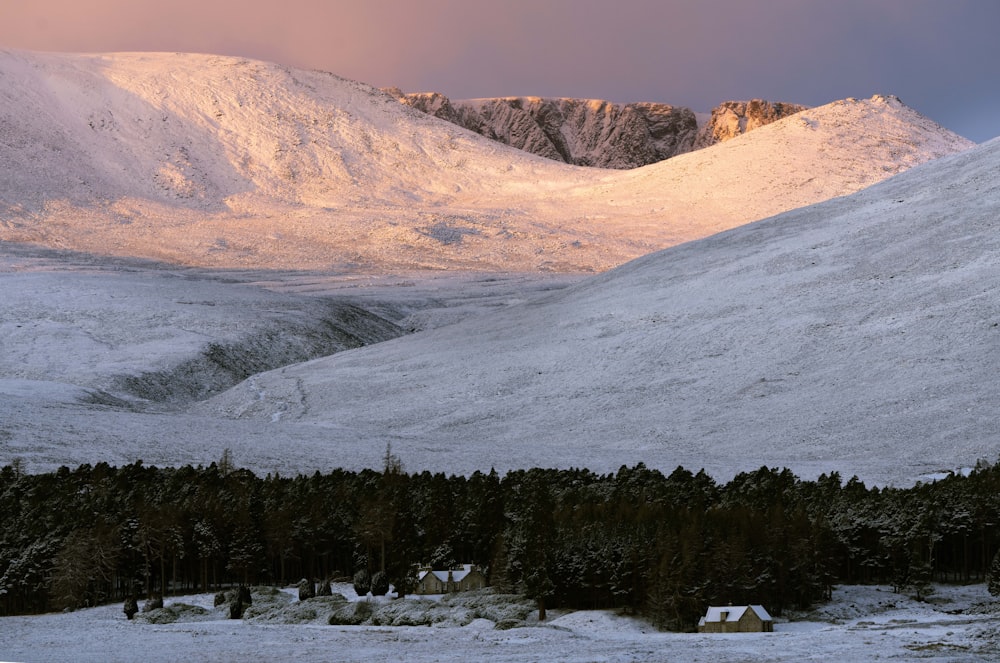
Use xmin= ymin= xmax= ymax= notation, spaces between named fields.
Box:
xmin=0 ymin=585 xmax=1000 ymax=663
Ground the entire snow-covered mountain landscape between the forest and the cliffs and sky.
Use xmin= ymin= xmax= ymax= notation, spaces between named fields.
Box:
xmin=0 ymin=52 xmax=988 ymax=481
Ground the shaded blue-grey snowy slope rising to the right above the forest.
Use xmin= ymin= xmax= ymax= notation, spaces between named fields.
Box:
xmin=197 ymin=137 xmax=1000 ymax=481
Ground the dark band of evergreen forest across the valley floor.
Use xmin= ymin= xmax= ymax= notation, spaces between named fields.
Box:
xmin=0 ymin=460 xmax=1000 ymax=629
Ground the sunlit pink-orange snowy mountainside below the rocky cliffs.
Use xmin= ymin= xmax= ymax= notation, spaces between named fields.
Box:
xmin=0 ymin=51 xmax=971 ymax=273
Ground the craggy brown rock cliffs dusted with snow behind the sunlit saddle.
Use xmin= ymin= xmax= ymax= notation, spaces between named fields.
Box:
xmin=387 ymin=88 xmax=805 ymax=169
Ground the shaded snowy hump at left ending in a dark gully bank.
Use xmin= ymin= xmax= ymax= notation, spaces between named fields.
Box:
xmin=0 ymin=267 xmax=403 ymax=404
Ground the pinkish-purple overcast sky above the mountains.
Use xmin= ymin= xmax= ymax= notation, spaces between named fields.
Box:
xmin=0 ymin=0 xmax=1000 ymax=141
